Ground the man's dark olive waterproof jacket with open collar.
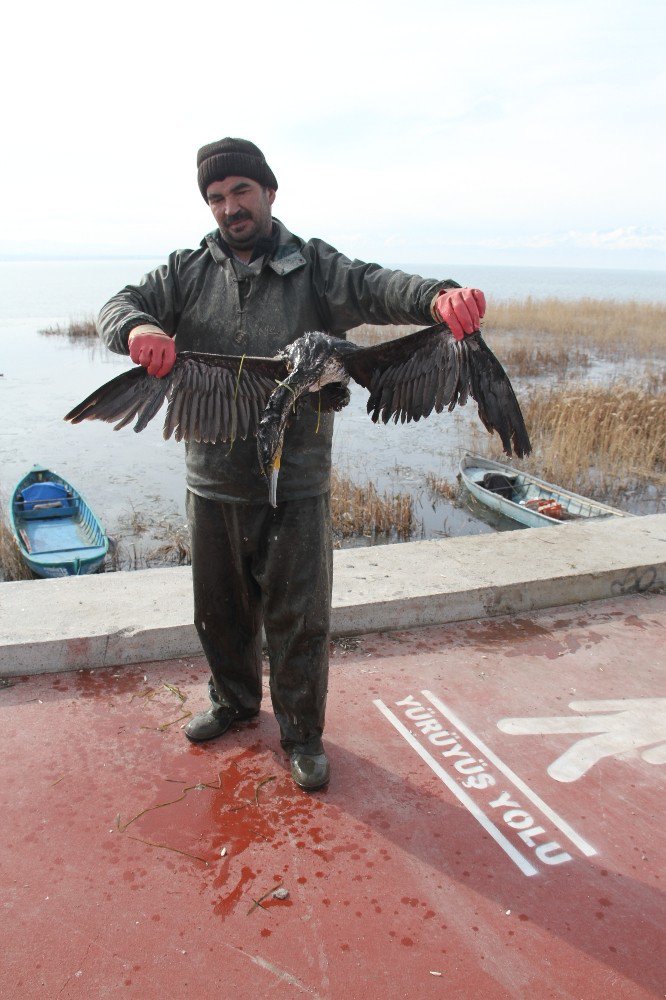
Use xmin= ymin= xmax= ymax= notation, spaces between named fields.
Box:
xmin=98 ymin=220 xmax=459 ymax=503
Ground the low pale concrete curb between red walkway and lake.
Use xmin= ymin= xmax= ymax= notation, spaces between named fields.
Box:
xmin=0 ymin=514 xmax=666 ymax=676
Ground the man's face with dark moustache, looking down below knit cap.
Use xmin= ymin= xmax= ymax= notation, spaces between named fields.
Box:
xmin=206 ymin=177 xmax=275 ymax=250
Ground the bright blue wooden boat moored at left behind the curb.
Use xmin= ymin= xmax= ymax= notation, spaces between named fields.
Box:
xmin=9 ymin=465 xmax=109 ymax=577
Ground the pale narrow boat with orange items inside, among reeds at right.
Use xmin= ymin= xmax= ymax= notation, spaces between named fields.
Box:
xmin=460 ymin=452 xmax=634 ymax=528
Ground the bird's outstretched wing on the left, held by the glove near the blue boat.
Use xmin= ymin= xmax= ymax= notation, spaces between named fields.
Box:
xmin=65 ymin=351 xmax=287 ymax=444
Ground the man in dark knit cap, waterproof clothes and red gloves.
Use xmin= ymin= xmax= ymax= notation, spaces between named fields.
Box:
xmin=98 ymin=138 xmax=485 ymax=791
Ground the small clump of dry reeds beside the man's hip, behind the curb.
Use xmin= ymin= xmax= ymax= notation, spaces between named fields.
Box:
xmin=331 ymin=469 xmax=414 ymax=539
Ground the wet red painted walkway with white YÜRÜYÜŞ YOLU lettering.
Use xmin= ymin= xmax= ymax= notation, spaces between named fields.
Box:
xmin=0 ymin=596 xmax=666 ymax=1000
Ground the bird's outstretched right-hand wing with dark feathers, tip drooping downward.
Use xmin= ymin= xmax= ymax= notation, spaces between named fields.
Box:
xmin=345 ymin=323 xmax=531 ymax=458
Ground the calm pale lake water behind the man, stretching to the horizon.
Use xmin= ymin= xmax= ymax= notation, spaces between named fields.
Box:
xmin=0 ymin=260 xmax=666 ymax=572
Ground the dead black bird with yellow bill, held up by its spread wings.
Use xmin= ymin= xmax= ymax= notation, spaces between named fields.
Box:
xmin=65 ymin=323 xmax=532 ymax=506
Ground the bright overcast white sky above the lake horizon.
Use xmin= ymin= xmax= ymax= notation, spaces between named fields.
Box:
xmin=0 ymin=0 xmax=666 ymax=268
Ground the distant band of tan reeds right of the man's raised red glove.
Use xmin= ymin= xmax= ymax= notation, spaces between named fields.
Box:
xmin=486 ymin=298 xmax=666 ymax=357
